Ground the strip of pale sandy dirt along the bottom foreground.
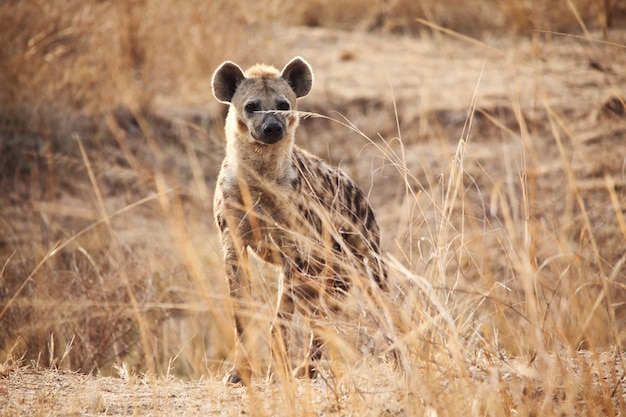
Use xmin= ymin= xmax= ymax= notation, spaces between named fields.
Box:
xmin=0 ymin=352 xmax=626 ymax=417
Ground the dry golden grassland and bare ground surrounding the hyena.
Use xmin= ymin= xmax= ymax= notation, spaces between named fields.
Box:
xmin=0 ymin=0 xmax=626 ymax=416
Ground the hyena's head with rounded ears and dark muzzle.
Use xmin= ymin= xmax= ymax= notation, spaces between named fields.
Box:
xmin=212 ymin=57 xmax=313 ymax=145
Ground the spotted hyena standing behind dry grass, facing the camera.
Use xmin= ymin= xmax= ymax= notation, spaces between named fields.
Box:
xmin=213 ymin=57 xmax=386 ymax=384
